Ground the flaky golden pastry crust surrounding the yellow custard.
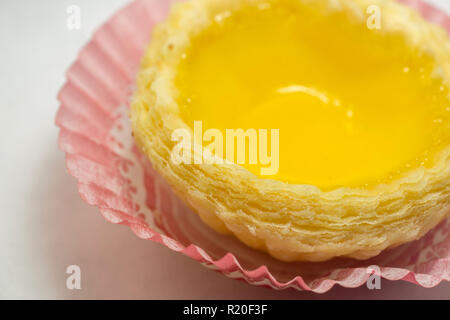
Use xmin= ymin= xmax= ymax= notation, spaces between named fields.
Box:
xmin=131 ymin=0 xmax=450 ymax=261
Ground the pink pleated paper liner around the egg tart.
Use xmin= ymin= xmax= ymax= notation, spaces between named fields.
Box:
xmin=56 ymin=0 xmax=450 ymax=293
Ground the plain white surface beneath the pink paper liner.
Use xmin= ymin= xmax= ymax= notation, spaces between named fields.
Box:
xmin=0 ymin=0 xmax=450 ymax=299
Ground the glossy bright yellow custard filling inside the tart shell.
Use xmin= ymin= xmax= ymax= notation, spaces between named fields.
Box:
xmin=176 ymin=2 xmax=450 ymax=190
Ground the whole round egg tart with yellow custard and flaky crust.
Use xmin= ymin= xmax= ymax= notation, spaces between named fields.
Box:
xmin=131 ymin=0 xmax=450 ymax=261
